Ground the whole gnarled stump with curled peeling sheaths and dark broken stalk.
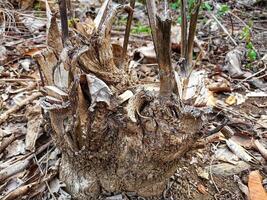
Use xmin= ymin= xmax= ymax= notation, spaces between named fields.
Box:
xmin=37 ymin=3 xmax=202 ymax=199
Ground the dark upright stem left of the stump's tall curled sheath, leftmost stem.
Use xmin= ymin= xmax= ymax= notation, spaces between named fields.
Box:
xmin=59 ymin=0 xmax=69 ymax=44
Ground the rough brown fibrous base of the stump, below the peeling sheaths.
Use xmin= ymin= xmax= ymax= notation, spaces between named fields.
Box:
xmin=50 ymin=91 xmax=201 ymax=199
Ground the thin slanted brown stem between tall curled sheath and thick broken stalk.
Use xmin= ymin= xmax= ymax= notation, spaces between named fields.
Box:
xmin=122 ymin=0 xmax=135 ymax=62
